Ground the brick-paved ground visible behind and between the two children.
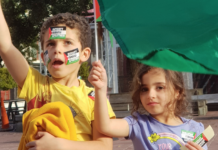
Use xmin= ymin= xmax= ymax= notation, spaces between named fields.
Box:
xmin=0 ymin=111 xmax=218 ymax=150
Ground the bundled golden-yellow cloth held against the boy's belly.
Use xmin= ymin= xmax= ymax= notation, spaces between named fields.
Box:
xmin=18 ymin=102 xmax=77 ymax=150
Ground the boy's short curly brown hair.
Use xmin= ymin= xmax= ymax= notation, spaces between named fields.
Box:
xmin=40 ymin=13 xmax=92 ymax=49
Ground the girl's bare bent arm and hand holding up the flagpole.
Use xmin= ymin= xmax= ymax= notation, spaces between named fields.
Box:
xmin=89 ymin=62 xmax=129 ymax=137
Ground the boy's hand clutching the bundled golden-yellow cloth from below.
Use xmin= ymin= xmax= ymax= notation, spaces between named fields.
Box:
xmin=26 ymin=132 xmax=60 ymax=150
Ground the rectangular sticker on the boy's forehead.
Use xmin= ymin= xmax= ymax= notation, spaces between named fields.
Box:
xmin=49 ymin=27 xmax=66 ymax=40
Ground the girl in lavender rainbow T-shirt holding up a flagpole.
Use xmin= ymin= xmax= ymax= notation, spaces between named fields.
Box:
xmin=89 ymin=62 xmax=207 ymax=150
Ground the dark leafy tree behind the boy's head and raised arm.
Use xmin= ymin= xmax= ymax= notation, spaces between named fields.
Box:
xmin=0 ymin=0 xmax=93 ymax=67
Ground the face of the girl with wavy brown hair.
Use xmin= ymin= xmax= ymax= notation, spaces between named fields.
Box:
xmin=140 ymin=68 xmax=177 ymax=115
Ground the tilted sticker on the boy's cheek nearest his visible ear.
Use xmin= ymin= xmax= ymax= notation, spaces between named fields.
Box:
xmin=64 ymin=48 xmax=79 ymax=65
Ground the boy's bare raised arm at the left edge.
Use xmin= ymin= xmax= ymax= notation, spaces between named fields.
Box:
xmin=0 ymin=2 xmax=29 ymax=88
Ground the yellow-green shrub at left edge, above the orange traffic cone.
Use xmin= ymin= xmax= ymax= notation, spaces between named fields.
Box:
xmin=0 ymin=68 xmax=17 ymax=90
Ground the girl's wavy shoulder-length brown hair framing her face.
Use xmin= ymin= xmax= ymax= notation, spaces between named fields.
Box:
xmin=131 ymin=64 xmax=188 ymax=118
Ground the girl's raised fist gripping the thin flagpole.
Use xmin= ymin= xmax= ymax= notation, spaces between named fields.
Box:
xmin=88 ymin=61 xmax=107 ymax=90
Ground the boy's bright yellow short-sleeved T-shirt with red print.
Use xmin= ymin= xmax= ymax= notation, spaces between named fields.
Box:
xmin=18 ymin=67 xmax=115 ymax=141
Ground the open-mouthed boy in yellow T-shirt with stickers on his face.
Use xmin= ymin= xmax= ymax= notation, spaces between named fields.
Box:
xmin=0 ymin=2 xmax=115 ymax=150
